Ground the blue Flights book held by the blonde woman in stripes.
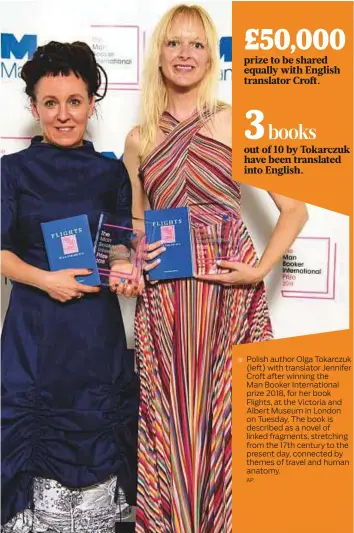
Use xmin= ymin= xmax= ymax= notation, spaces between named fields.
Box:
xmin=145 ymin=207 xmax=193 ymax=281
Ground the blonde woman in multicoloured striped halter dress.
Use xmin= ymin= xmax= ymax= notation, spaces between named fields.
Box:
xmin=125 ymin=6 xmax=306 ymax=533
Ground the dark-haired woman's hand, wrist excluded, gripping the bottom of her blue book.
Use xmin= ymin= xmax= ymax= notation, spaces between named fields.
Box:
xmin=41 ymin=268 xmax=100 ymax=303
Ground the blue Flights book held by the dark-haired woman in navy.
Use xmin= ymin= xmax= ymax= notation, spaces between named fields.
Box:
xmin=41 ymin=215 xmax=100 ymax=286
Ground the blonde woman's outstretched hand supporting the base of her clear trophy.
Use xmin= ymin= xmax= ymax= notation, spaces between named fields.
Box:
xmin=195 ymin=261 xmax=264 ymax=287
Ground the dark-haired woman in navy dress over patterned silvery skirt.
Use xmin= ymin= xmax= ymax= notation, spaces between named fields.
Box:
xmin=2 ymin=42 xmax=137 ymax=533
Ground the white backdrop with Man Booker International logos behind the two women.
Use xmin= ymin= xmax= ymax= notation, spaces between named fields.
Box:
xmin=0 ymin=0 xmax=349 ymax=345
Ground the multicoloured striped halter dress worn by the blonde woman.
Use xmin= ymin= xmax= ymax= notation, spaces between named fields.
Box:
xmin=136 ymin=112 xmax=272 ymax=533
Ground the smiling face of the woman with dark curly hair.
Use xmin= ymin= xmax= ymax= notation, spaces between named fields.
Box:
xmin=31 ymin=73 xmax=94 ymax=148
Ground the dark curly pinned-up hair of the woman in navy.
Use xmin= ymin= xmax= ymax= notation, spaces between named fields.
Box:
xmin=21 ymin=41 xmax=107 ymax=102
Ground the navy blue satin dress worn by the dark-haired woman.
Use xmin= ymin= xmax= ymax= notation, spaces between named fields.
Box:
xmin=1 ymin=137 xmax=137 ymax=523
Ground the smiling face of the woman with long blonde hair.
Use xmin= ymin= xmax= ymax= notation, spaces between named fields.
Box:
xmin=160 ymin=15 xmax=210 ymax=90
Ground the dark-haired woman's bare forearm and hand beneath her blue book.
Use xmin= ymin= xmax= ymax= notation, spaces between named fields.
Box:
xmin=1 ymin=250 xmax=100 ymax=302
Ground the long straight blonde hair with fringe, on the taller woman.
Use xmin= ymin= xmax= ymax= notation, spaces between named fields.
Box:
xmin=139 ymin=4 xmax=220 ymax=160
